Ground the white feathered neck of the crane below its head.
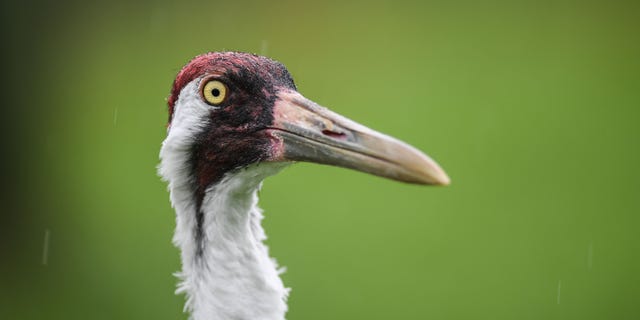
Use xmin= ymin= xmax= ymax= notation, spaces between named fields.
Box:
xmin=170 ymin=164 xmax=288 ymax=320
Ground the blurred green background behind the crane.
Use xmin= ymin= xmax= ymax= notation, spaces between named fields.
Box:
xmin=0 ymin=1 xmax=640 ymax=320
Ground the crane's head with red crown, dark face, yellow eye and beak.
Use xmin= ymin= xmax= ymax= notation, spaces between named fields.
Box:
xmin=163 ymin=52 xmax=449 ymax=196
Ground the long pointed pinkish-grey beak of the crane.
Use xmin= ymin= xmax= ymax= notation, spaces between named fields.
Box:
xmin=268 ymin=90 xmax=450 ymax=185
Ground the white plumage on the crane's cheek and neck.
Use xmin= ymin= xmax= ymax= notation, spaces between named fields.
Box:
xmin=159 ymin=80 xmax=289 ymax=320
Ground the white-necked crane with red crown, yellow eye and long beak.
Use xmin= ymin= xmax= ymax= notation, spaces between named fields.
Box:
xmin=158 ymin=52 xmax=449 ymax=320
